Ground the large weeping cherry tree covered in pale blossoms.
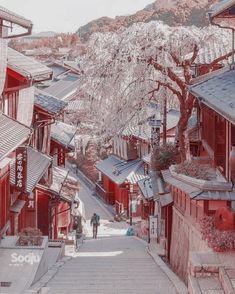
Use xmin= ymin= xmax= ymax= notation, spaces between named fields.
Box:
xmin=75 ymin=22 xmax=231 ymax=161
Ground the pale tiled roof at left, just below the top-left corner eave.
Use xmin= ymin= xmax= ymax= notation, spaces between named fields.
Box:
xmin=7 ymin=48 xmax=52 ymax=81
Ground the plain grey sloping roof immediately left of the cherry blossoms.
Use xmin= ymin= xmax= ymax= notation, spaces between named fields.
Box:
xmin=45 ymin=80 xmax=80 ymax=100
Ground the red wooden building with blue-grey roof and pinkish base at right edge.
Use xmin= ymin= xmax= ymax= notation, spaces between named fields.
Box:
xmin=162 ymin=1 xmax=235 ymax=281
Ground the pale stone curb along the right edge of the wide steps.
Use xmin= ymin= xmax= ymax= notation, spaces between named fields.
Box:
xmin=134 ymin=236 xmax=189 ymax=294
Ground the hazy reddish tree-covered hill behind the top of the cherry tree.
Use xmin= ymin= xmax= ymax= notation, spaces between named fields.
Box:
xmin=76 ymin=0 xmax=218 ymax=41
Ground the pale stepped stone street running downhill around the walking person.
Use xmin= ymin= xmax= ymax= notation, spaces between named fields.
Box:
xmin=46 ymin=172 xmax=176 ymax=294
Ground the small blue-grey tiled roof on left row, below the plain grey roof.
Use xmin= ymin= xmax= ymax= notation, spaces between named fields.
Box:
xmin=34 ymin=89 xmax=67 ymax=114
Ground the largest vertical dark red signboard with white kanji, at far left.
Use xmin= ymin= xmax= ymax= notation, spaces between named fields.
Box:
xmin=15 ymin=147 xmax=27 ymax=192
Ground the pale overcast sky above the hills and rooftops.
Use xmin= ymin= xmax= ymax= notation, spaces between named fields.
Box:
xmin=0 ymin=0 xmax=154 ymax=32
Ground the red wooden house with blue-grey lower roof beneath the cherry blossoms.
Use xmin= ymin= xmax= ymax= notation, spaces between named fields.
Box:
xmin=96 ymin=107 xmax=182 ymax=220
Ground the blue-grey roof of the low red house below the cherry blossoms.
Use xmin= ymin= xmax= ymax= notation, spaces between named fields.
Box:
xmin=96 ymin=155 xmax=145 ymax=185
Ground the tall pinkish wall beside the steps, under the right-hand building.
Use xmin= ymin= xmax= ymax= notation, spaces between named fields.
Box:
xmin=170 ymin=207 xmax=211 ymax=283
